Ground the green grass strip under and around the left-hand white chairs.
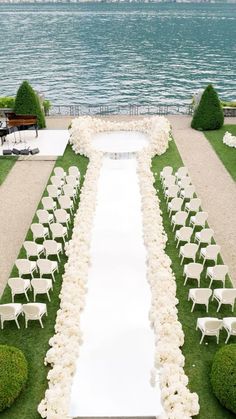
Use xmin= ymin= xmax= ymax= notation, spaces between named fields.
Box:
xmin=0 ymin=146 xmax=88 ymax=419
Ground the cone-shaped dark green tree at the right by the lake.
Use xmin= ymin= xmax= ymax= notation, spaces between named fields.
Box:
xmin=191 ymin=84 xmax=224 ymax=131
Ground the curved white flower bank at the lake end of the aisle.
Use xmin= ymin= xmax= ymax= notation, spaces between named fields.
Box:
xmin=70 ymin=116 xmax=171 ymax=157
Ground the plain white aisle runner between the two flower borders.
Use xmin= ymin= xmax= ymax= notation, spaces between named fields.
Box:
xmin=70 ymin=158 xmax=162 ymax=417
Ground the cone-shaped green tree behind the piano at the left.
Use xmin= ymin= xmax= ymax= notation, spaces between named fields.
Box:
xmin=14 ymin=80 xmax=46 ymax=128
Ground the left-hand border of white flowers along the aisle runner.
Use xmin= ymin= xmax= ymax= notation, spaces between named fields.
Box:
xmin=38 ymin=152 xmax=102 ymax=419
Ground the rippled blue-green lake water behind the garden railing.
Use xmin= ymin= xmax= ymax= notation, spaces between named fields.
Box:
xmin=0 ymin=3 xmax=236 ymax=105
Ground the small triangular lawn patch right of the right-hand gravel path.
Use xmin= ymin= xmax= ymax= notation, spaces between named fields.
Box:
xmin=204 ymin=125 xmax=236 ymax=180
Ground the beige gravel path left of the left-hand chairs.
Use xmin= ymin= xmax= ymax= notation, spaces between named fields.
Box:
xmin=0 ymin=161 xmax=55 ymax=295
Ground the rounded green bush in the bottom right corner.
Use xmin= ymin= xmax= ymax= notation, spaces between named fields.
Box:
xmin=211 ymin=344 xmax=236 ymax=414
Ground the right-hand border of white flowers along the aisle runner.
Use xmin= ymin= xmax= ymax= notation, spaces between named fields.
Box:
xmin=138 ymin=150 xmax=199 ymax=419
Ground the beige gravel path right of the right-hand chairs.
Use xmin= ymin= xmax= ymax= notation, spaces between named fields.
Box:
xmin=168 ymin=116 xmax=236 ymax=285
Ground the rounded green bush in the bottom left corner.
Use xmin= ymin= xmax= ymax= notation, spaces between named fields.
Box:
xmin=0 ymin=345 xmax=28 ymax=412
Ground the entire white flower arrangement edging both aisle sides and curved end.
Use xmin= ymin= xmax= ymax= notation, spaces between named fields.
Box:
xmin=38 ymin=117 xmax=199 ymax=419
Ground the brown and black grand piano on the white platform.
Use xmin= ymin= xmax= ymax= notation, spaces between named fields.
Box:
xmin=0 ymin=112 xmax=38 ymax=145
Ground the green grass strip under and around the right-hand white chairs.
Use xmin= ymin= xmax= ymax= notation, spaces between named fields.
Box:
xmin=152 ymin=141 xmax=235 ymax=419
